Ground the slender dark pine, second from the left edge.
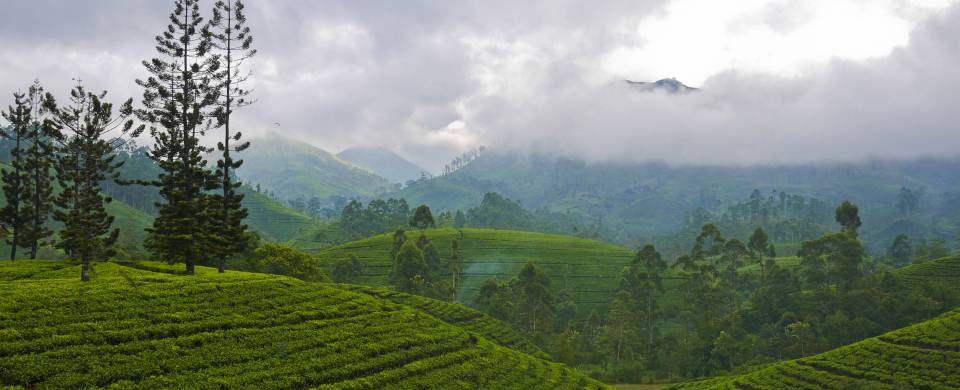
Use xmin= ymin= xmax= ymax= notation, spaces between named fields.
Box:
xmin=18 ymin=81 xmax=58 ymax=259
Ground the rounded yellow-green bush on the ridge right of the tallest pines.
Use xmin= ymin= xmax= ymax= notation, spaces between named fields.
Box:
xmin=247 ymin=242 xmax=330 ymax=282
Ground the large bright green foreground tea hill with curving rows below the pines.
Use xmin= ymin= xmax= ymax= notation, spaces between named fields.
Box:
xmin=0 ymin=261 xmax=604 ymax=389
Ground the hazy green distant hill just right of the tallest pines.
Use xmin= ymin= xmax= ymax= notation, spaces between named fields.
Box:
xmin=238 ymin=134 xmax=389 ymax=201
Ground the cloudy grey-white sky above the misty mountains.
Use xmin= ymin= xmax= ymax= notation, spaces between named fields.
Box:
xmin=0 ymin=0 xmax=960 ymax=172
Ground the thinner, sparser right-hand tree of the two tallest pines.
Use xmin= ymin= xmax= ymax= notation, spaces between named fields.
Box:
xmin=205 ymin=0 xmax=256 ymax=272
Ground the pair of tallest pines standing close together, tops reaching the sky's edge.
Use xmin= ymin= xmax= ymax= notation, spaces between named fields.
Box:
xmin=136 ymin=0 xmax=255 ymax=274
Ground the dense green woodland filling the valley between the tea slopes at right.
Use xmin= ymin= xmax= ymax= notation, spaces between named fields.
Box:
xmin=462 ymin=202 xmax=960 ymax=383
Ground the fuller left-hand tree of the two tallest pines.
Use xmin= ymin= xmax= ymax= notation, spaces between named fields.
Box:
xmin=137 ymin=0 xmax=220 ymax=274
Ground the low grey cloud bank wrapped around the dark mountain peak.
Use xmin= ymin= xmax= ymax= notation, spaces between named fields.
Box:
xmin=465 ymin=3 xmax=960 ymax=164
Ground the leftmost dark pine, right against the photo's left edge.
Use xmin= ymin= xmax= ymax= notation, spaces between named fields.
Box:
xmin=0 ymin=92 xmax=32 ymax=260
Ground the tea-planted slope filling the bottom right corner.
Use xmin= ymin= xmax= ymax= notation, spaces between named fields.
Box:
xmin=671 ymin=310 xmax=960 ymax=390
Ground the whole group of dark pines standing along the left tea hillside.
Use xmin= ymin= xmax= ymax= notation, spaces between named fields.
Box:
xmin=0 ymin=0 xmax=256 ymax=280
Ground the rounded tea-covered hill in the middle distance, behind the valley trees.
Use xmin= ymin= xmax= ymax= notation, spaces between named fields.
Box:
xmin=317 ymin=229 xmax=633 ymax=306
